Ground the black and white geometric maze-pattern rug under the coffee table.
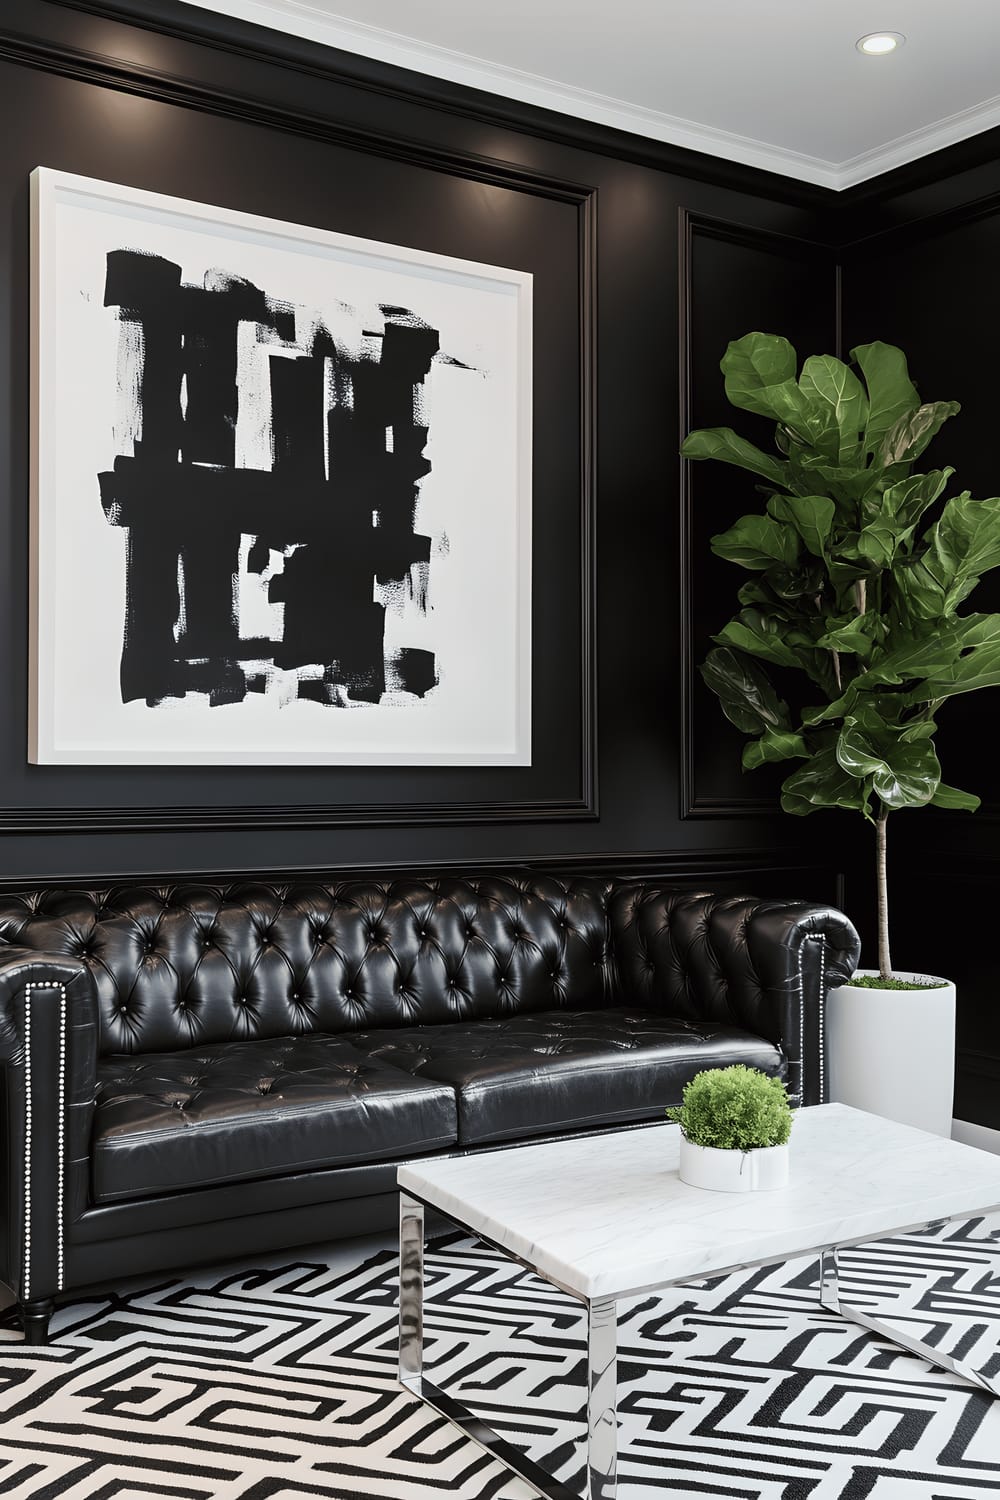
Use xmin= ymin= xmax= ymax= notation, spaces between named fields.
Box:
xmin=0 ymin=1220 xmax=1000 ymax=1500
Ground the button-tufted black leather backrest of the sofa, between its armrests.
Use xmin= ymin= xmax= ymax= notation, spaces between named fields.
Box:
xmin=0 ymin=873 xmax=613 ymax=1053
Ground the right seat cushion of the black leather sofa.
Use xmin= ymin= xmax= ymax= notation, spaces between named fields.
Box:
xmin=351 ymin=1010 xmax=784 ymax=1146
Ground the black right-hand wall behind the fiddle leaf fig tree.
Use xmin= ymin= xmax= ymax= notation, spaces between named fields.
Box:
xmin=843 ymin=132 xmax=1000 ymax=1128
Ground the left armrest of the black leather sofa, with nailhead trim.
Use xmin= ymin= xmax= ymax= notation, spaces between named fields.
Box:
xmin=0 ymin=945 xmax=97 ymax=1302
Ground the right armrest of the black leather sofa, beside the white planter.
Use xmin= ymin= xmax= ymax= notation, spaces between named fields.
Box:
xmin=610 ymin=885 xmax=861 ymax=1104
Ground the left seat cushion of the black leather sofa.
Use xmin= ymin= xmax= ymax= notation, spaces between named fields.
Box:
xmin=91 ymin=1035 xmax=457 ymax=1203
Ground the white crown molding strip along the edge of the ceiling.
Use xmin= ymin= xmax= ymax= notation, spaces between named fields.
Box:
xmin=177 ymin=0 xmax=1000 ymax=192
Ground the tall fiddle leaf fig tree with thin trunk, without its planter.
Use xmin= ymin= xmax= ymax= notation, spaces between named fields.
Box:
xmin=682 ymin=333 xmax=1000 ymax=978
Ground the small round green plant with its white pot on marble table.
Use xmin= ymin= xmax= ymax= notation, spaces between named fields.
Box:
xmin=667 ymin=1062 xmax=793 ymax=1193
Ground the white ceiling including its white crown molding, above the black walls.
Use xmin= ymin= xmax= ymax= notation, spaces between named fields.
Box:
xmin=176 ymin=0 xmax=1000 ymax=189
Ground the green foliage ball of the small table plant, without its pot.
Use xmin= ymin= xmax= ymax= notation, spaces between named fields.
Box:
xmin=667 ymin=1062 xmax=792 ymax=1151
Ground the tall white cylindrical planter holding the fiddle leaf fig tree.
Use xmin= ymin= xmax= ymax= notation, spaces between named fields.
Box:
xmin=826 ymin=969 xmax=955 ymax=1136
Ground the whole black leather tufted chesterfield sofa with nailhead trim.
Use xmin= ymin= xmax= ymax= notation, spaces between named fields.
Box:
xmin=0 ymin=872 xmax=858 ymax=1343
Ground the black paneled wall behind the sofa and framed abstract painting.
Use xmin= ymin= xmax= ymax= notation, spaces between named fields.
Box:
xmin=0 ymin=0 xmax=1000 ymax=1125
